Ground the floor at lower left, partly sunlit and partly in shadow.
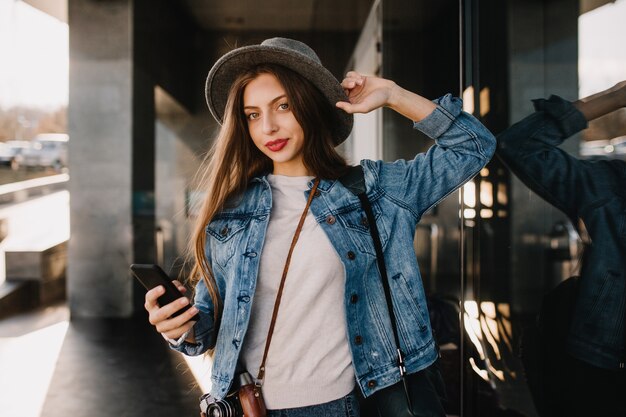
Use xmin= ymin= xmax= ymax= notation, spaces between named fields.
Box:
xmin=0 ymin=305 xmax=201 ymax=417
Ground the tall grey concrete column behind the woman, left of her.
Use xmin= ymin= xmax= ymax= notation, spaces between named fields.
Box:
xmin=68 ymin=0 xmax=133 ymax=317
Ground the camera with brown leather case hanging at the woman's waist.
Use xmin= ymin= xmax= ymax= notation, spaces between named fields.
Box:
xmin=200 ymin=372 xmax=267 ymax=417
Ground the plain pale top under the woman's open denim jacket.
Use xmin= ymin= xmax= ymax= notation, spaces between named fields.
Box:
xmin=241 ymin=175 xmax=355 ymax=410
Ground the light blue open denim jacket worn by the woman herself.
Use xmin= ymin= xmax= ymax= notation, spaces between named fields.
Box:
xmin=176 ymin=95 xmax=495 ymax=398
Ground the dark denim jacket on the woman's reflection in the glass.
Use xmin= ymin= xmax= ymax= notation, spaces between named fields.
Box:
xmin=498 ymin=96 xmax=626 ymax=369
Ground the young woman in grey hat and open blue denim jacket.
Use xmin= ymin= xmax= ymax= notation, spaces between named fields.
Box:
xmin=146 ymin=38 xmax=495 ymax=416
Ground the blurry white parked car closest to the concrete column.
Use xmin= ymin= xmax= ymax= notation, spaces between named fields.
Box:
xmin=22 ymin=133 xmax=69 ymax=170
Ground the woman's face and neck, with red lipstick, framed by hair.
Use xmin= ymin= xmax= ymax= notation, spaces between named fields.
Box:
xmin=243 ymin=74 xmax=310 ymax=176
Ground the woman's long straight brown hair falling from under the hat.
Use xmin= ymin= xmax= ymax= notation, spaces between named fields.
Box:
xmin=190 ymin=64 xmax=347 ymax=328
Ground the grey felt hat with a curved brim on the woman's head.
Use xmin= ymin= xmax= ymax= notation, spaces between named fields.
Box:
xmin=205 ymin=38 xmax=354 ymax=145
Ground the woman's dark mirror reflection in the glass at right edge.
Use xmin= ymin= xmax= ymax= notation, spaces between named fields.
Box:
xmin=498 ymin=81 xmax=626 ymax=416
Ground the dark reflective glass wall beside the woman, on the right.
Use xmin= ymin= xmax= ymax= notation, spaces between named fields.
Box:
xmin=381 ymin=0 xmax=626 ymax=417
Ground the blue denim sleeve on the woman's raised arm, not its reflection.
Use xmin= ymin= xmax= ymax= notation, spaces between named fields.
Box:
xmin=363 ymin=94 xmax=495 ymax=220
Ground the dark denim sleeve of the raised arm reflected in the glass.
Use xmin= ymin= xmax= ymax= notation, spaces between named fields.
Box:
xmin=497 ymin=96 xmax=615 ymax=220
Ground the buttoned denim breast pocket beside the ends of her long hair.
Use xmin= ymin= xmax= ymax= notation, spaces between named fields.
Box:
xmin=206 ymin=217 xmax=250 ymax=266
